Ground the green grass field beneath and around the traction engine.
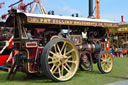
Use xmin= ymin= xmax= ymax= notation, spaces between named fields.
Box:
xmin=0 ymin=58 xmax=128 ymax=85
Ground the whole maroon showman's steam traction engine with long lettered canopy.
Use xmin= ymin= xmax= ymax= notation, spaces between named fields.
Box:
xmin=3 ymin=10 xmax=117 ymax=81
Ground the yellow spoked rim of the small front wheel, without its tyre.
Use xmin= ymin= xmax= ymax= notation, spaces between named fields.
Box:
xmin=101 ymin=53 xmax=113 ymax=72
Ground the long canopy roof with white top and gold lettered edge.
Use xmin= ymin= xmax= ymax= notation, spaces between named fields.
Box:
xmin=24 ymin=13 xmax=118 ymax=27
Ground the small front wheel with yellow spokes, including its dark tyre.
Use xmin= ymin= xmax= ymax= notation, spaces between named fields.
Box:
xmin=97 ymin=51 xmax=113 ymax=74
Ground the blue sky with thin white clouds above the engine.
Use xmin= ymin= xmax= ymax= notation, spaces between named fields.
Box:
xmin=0 ymin=0 xmax=128 ymax=22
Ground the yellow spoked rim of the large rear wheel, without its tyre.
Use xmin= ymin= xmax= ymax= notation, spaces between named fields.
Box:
xmin=48 ymin=40 xmax=79 ymax=81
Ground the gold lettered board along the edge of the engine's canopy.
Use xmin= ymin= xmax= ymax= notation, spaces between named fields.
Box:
xmin=27 ymin=17 xmax=118 ymax=27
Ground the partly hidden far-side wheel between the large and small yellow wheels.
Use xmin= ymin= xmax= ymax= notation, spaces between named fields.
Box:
xmin=80 ymin=53 xmax=91 ymax=71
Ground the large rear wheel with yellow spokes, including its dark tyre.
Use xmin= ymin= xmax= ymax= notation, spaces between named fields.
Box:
xmin=41 ymin=38 xmax=79 ymax=81
